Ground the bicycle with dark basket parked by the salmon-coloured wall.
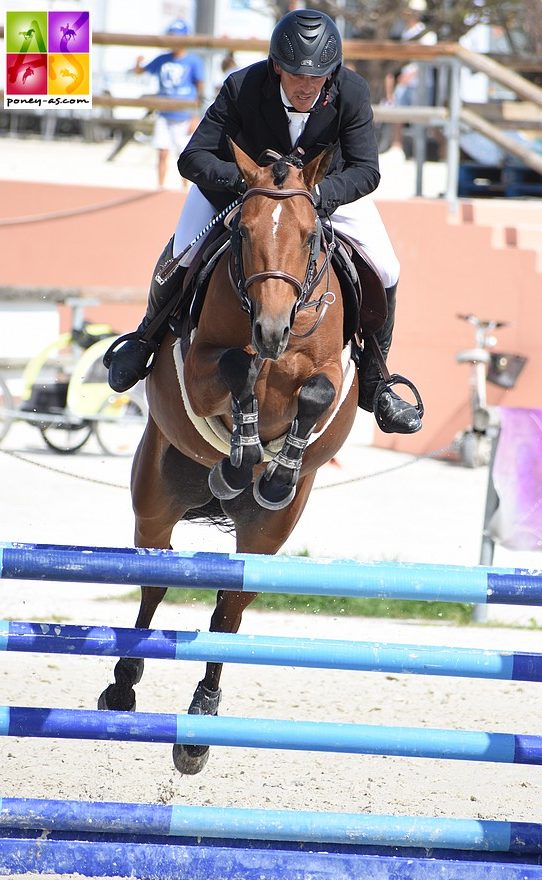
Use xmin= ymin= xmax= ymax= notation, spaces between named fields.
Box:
xmin=454 ymin=314 xmax=527 ymax=468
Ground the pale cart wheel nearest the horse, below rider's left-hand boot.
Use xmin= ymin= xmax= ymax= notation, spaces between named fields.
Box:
xmin=95 ymin=391 xmax=148 ymax=456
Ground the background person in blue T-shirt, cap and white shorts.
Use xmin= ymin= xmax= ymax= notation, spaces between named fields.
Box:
xmin=134 ymin=19 xmax=204 ymax=187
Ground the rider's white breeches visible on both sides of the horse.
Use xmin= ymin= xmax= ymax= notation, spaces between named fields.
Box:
xmin=173 ymin=186 xmax=400 ymax=287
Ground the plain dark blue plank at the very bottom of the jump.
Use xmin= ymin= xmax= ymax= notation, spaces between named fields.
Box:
xmin=4 ymin=834 xmax=542 ymax=880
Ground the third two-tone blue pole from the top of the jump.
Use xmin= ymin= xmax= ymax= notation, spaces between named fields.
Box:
xmin=0 ymin=706 xmax=542 ymax=764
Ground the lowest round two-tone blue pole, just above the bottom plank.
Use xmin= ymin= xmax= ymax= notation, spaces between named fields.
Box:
xmin=0 ymin=798 xmax=542 ymax=855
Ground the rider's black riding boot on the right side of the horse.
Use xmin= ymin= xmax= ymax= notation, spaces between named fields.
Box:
xmin=358 ymin=284 xmax=423 ymax=434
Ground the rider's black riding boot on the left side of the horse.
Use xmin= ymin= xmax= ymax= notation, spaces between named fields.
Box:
xmin=103 ymin=238 xmax=186 ymax=392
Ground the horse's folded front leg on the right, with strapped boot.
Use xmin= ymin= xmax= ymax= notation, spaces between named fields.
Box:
xmin=254 ymin=373 xmax=335 ymax=510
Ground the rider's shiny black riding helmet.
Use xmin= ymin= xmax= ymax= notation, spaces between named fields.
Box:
xmin=269 ymin=9 xmax=342 ymax=76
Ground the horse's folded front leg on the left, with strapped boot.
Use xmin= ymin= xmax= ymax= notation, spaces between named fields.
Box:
xmin=209 ymin=348 xmax=263 ymax=501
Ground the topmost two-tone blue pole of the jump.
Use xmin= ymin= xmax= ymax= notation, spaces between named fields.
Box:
xmin=0 ymin=543 xmax=542 ymax=605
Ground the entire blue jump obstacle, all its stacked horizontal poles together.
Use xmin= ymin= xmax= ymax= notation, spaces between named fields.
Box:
xmin=0 ymin=544 xmax=542 ymax=880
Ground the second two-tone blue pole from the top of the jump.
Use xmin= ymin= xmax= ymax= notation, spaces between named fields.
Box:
xmin=0 ymin=620 xmax=542 ymax=681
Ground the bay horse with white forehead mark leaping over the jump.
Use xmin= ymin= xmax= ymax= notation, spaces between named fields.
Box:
xmin=98 ymin=143 xmax=358 ymax=774
